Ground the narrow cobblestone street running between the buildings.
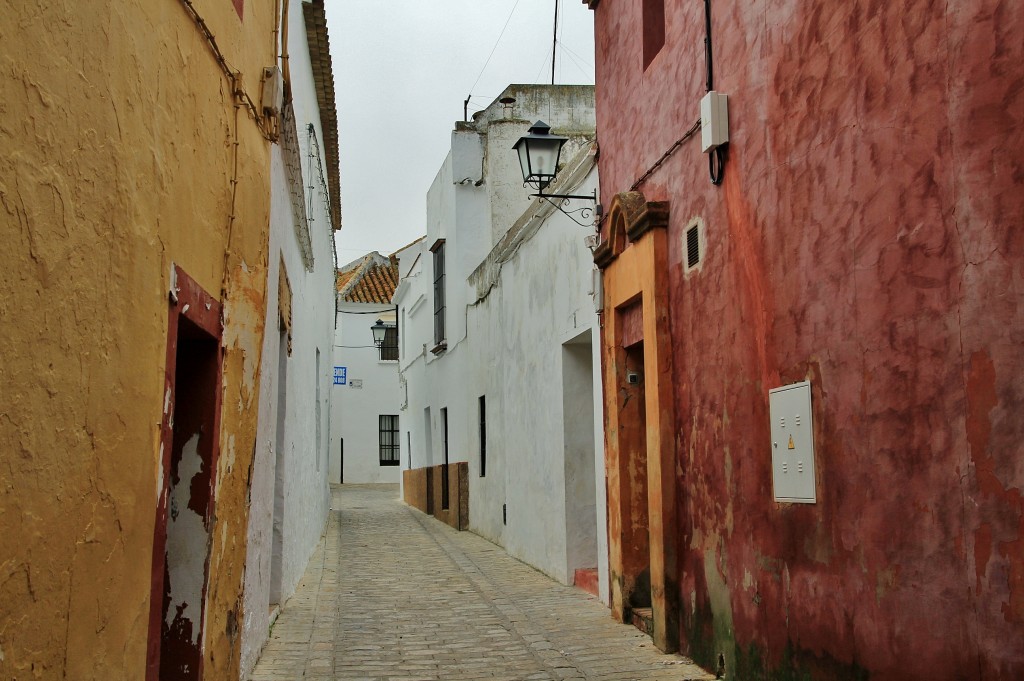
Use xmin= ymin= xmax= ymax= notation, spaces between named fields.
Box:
xmin=250 ymin=485 xmax=714 ymax=681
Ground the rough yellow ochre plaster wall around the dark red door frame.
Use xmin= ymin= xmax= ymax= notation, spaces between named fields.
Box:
xmin=0 ymin=0 xmax=276 ymax=679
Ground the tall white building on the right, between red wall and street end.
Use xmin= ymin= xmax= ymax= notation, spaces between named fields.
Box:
xmin=394 ymin=85 xmax=608 ymax=602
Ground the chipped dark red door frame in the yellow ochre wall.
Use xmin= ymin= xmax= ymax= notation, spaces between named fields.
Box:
xmin=145 ymin=265 xmax=223 ymax=681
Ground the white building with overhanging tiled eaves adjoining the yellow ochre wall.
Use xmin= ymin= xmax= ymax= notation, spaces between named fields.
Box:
xmin=241 ymin=0 xmax=340 ymax=679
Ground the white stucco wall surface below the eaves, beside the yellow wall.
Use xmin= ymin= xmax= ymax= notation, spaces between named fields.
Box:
xmin=241 ymin=0 xmax=335 ymax=678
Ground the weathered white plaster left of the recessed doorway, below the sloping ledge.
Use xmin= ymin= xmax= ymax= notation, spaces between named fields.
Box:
xmin=466 ymin=164 xmax=604 ymax=584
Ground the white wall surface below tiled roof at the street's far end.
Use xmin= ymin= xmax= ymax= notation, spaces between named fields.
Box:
xmin=330 ymin=303 xmax=404 ymax=484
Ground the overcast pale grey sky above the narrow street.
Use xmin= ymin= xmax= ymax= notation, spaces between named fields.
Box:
xmin=326 ymin=0 xmax=594 ymax=265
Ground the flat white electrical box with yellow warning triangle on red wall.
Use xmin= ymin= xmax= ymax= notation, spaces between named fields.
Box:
xmin=768 ymin=381 xmax=817 ymax=504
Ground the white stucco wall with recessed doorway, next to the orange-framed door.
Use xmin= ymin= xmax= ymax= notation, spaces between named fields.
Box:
xmin=469 ymin=161 xmax=606 ymax=584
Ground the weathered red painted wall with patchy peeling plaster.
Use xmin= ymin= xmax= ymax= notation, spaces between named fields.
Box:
xmin=592 ymin=0 xmax=1024 ymax=681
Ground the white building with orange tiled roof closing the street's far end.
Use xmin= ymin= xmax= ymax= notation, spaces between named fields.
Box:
xmin=330 ymin=252 xmax=402 ymax=484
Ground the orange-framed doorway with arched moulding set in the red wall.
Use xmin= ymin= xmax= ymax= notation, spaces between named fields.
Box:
xmin=602 ymin=225 xmax=679 ymax=651
